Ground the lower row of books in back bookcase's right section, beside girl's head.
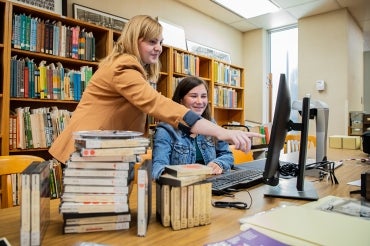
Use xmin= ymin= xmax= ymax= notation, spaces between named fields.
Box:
xmin=213 ymin=86 xmax=238 ymax=108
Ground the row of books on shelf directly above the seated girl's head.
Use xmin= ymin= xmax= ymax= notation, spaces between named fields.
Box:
xmin=173 ymin=50 xmax=200 ymax=76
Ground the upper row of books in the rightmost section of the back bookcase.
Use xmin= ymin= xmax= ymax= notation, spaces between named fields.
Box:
xmin=213 ymin=61 xmax=241 ymax=87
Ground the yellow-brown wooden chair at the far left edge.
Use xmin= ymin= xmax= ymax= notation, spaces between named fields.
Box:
xmin=0 ymin=155 xmax=44 ymax=208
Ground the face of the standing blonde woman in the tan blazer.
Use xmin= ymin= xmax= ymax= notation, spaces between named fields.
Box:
xmin=139 ymin=35 xmax=163 ymax=65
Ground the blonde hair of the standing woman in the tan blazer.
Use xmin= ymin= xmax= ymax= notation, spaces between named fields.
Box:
xmin=99 ymin=15 xmax=162 ymax=82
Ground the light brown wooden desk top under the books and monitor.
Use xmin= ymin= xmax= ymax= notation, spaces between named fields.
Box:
xmin=0 ymin=149 xmax=370 ymax=246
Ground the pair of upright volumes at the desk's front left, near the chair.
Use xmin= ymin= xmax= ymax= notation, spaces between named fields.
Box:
xmin=20 ymin=161 xmax=50 ymax=245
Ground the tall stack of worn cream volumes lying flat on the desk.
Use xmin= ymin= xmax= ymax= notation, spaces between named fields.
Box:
xmin=60 ymin=131 xmax=149 ymax=233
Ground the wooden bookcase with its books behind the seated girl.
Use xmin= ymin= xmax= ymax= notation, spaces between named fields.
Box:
xmin=157 ymin=47 xmax=244 ymax=128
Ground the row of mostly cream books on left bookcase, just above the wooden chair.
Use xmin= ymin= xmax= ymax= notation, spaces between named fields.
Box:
xmin=9 ymin=106 xmax=72 ymax=150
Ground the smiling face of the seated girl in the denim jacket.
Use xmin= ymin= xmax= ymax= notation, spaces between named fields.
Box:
xmin=180 ymin=82 xmax=208 ymax=115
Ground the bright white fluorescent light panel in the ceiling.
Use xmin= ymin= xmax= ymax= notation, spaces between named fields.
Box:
xmin=211 ymin=0 xmax=280 ymax=19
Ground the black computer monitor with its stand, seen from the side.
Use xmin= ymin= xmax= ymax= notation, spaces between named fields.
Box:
xmin=263 ymin=74 xmax=318 ymax=200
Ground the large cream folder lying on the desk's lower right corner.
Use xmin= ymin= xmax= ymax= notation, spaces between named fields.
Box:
xmin=240 ymin=206 xmax=370 ymax=246
